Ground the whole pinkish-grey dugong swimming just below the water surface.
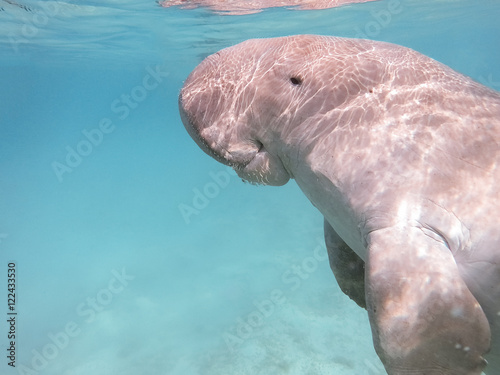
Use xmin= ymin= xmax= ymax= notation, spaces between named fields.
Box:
xmin=179 ymin=35 xmax=500 ymax=375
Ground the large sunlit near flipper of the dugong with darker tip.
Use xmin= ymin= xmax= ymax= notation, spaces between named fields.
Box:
xmin=366 ymin=226 xmax=490 ymax=375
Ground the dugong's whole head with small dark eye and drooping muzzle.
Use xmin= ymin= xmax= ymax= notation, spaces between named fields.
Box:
xmin=179 ymin=35 xmax=381 ymax=185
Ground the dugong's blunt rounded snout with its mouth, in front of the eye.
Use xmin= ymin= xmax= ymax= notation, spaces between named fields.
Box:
xmin=179 ymin=51 xmax=290 ymax=186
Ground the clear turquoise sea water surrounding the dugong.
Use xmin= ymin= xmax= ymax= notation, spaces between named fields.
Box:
xmin=0 ymin=0 xmax=500 ymax=375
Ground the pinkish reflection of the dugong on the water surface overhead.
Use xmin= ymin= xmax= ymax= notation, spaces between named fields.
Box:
xmin=160 ymin=0 xmax=375 ymax=16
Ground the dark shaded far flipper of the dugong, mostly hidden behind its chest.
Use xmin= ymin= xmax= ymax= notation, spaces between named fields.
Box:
xmin=324 ymin=220 xmax=366 ymax=308
